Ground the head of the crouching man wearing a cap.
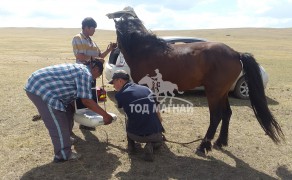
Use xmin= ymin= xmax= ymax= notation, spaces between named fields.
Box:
xmin=109 ymin=70 xmax=130 ymax=91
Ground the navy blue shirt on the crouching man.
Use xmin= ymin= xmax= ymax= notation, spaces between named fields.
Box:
xmin=115 ymin=83 xmax=163 ymax=136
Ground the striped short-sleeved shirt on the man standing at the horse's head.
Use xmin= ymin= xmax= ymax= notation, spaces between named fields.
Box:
xmin=72 ymin=32 xmax=101 ymax=62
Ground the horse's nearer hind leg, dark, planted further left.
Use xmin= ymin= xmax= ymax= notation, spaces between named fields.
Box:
xmin=197 ymin=96 xmax=222 ymax=154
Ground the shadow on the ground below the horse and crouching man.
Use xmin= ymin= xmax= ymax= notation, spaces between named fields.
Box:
xmin=116 ymin=145 xmax=275 ymax=180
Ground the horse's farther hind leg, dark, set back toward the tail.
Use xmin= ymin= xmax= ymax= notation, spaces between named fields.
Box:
xmin=215 ymin=95 xmax=232 ymax=148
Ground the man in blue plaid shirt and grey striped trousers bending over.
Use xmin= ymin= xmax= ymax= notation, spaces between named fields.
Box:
xmin=25 ymin=60 xmax=112 ymax=162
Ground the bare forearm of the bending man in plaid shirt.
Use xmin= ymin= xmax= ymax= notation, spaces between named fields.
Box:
xmin=81 ymin=98 xmax=113 ymax=125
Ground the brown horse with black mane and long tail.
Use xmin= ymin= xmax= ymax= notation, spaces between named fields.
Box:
xmin=109 ymin=15 xmax=284 ymax=153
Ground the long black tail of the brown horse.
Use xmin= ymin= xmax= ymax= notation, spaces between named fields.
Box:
xmin=241 ymin=53 xmax=285 ymax=144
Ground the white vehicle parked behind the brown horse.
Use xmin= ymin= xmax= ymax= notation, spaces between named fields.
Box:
xmin=104 ymin=36 xmax=269 ymax=99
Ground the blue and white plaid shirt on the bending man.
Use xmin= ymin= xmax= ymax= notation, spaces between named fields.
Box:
xmin=24 ymin=64 xmax=93 ymax=111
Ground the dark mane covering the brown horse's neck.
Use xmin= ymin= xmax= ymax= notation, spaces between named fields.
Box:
xmin=116 ymin=17 xmax=171 ymax=57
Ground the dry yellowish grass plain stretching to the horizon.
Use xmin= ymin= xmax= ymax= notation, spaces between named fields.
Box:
xmin=0 ymin=28 xmax=292 ymax=180
